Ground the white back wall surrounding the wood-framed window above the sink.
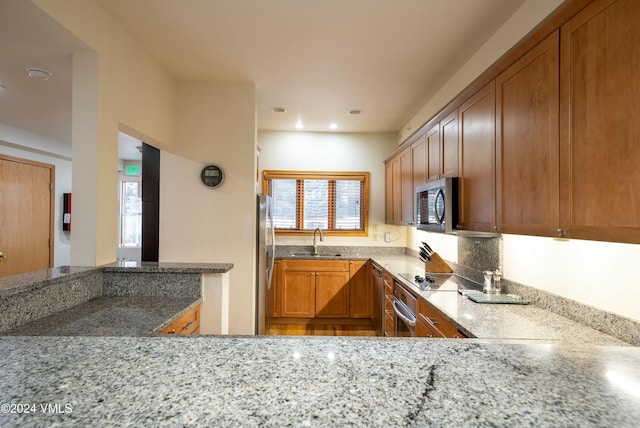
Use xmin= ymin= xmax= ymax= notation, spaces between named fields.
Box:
xmin=258 ymin=131 xmax=405 ymax=247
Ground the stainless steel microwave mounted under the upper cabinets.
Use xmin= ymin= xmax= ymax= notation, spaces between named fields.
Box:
xmin=416 ymin=177 xmax=459 ymax=233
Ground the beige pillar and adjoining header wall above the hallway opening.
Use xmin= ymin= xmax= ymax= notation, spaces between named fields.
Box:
xmin=33 ymin=0 xmax=175 ymax=265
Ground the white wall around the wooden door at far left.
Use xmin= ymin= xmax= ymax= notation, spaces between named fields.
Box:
xmin=0 ymin=124 xmax=73 ymax=266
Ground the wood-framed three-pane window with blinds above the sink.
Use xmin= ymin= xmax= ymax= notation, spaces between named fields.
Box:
xmin=263 ymin=171 xmax=369 ymax=236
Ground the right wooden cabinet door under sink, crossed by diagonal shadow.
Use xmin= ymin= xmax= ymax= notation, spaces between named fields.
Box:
xmin=315 ymin=272 xmax=349 ymax=318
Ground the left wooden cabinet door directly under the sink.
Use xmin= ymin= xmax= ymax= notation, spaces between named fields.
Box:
xmin=280 ymin=271 xmax=316 ymax=318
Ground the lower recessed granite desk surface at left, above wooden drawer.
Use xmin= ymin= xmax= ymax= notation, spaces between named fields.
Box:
xmin=0 ymin=296 xmax=202 ymax=336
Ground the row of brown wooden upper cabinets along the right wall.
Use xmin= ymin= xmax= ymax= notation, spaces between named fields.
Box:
xmin=386 ymin=0 xmax=640 ymax=243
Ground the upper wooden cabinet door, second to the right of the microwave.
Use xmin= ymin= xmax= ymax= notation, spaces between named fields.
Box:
xmin=496 ymin=31 xmax=560 ymax=236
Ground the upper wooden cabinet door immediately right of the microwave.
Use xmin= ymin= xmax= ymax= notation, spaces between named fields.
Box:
xmin=459 ymin=82 xmax=496 ymax=232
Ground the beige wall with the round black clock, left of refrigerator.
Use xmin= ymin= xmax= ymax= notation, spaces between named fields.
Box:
xmin=166 ymin=84 xmax=256 ymax=334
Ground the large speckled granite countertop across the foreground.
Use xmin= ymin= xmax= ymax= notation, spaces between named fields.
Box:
xmin=0 ymin=336 xmax=640 ymax=427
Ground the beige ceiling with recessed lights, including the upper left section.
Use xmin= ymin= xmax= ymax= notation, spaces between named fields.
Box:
xmin=0 ymin=0 xmax=524 ymax=147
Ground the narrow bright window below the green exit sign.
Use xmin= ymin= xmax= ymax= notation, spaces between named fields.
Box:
xmin=120 ymin=181 xmax=142 ymax=248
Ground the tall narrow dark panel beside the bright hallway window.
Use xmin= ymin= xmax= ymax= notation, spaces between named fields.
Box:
xmin=142 ymin=143 xmax=160 ymax=262
